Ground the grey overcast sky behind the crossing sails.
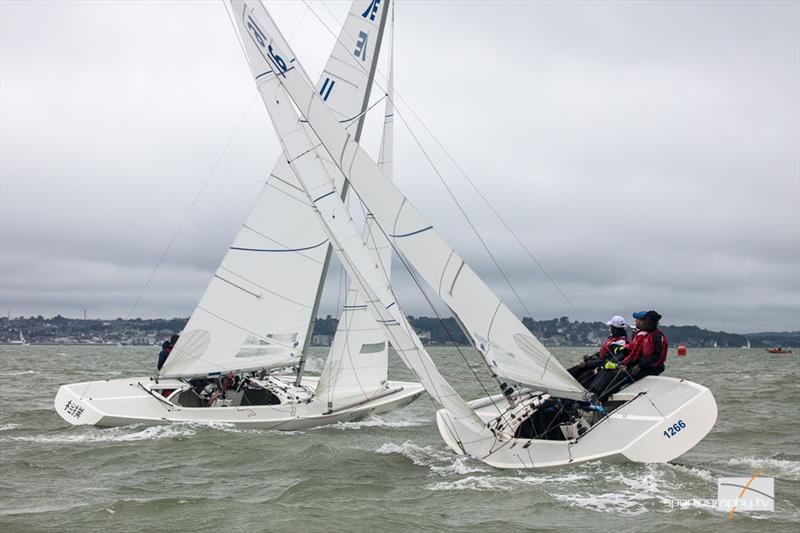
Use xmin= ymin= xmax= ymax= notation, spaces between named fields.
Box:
xmin=0 ymin=0 xmax=800 ymax=332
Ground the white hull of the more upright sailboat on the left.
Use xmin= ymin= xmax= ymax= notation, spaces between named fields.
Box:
xmin=54 ymin=377 xmax=424 ymax=431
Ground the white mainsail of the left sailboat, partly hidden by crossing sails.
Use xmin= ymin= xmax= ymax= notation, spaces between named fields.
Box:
xmin=160 ymin=0 xmax=386 ymax=377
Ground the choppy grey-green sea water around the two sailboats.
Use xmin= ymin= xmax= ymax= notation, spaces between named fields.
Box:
xmin=0 ymin=346 xmax=800 ymax=532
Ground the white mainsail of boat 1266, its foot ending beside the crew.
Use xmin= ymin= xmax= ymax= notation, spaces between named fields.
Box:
xmin=231 ymin=0 xmax=586 ymax=399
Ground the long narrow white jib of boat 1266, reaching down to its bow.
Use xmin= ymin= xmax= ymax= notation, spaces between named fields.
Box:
xmin=225 ymin=0 xmax=483 ymax=431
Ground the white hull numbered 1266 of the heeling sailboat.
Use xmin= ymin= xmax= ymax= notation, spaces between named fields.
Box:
xmin=436 ymin=376 xmax=717 ymax=468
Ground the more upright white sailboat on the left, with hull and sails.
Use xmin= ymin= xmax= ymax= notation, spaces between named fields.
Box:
xmin=55 ymin=0 xmax=423 ymax=430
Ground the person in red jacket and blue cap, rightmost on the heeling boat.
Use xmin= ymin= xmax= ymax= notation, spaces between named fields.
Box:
xmin=587 ymin=311 xmax=669 ymax=402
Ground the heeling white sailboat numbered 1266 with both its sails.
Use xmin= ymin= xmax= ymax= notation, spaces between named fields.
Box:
xmin=229 ymin=0 xmax=717 ymax=468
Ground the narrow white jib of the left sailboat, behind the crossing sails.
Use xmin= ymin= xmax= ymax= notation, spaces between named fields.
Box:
xmin=315 ymin=18 xmax=394 ymax=409
